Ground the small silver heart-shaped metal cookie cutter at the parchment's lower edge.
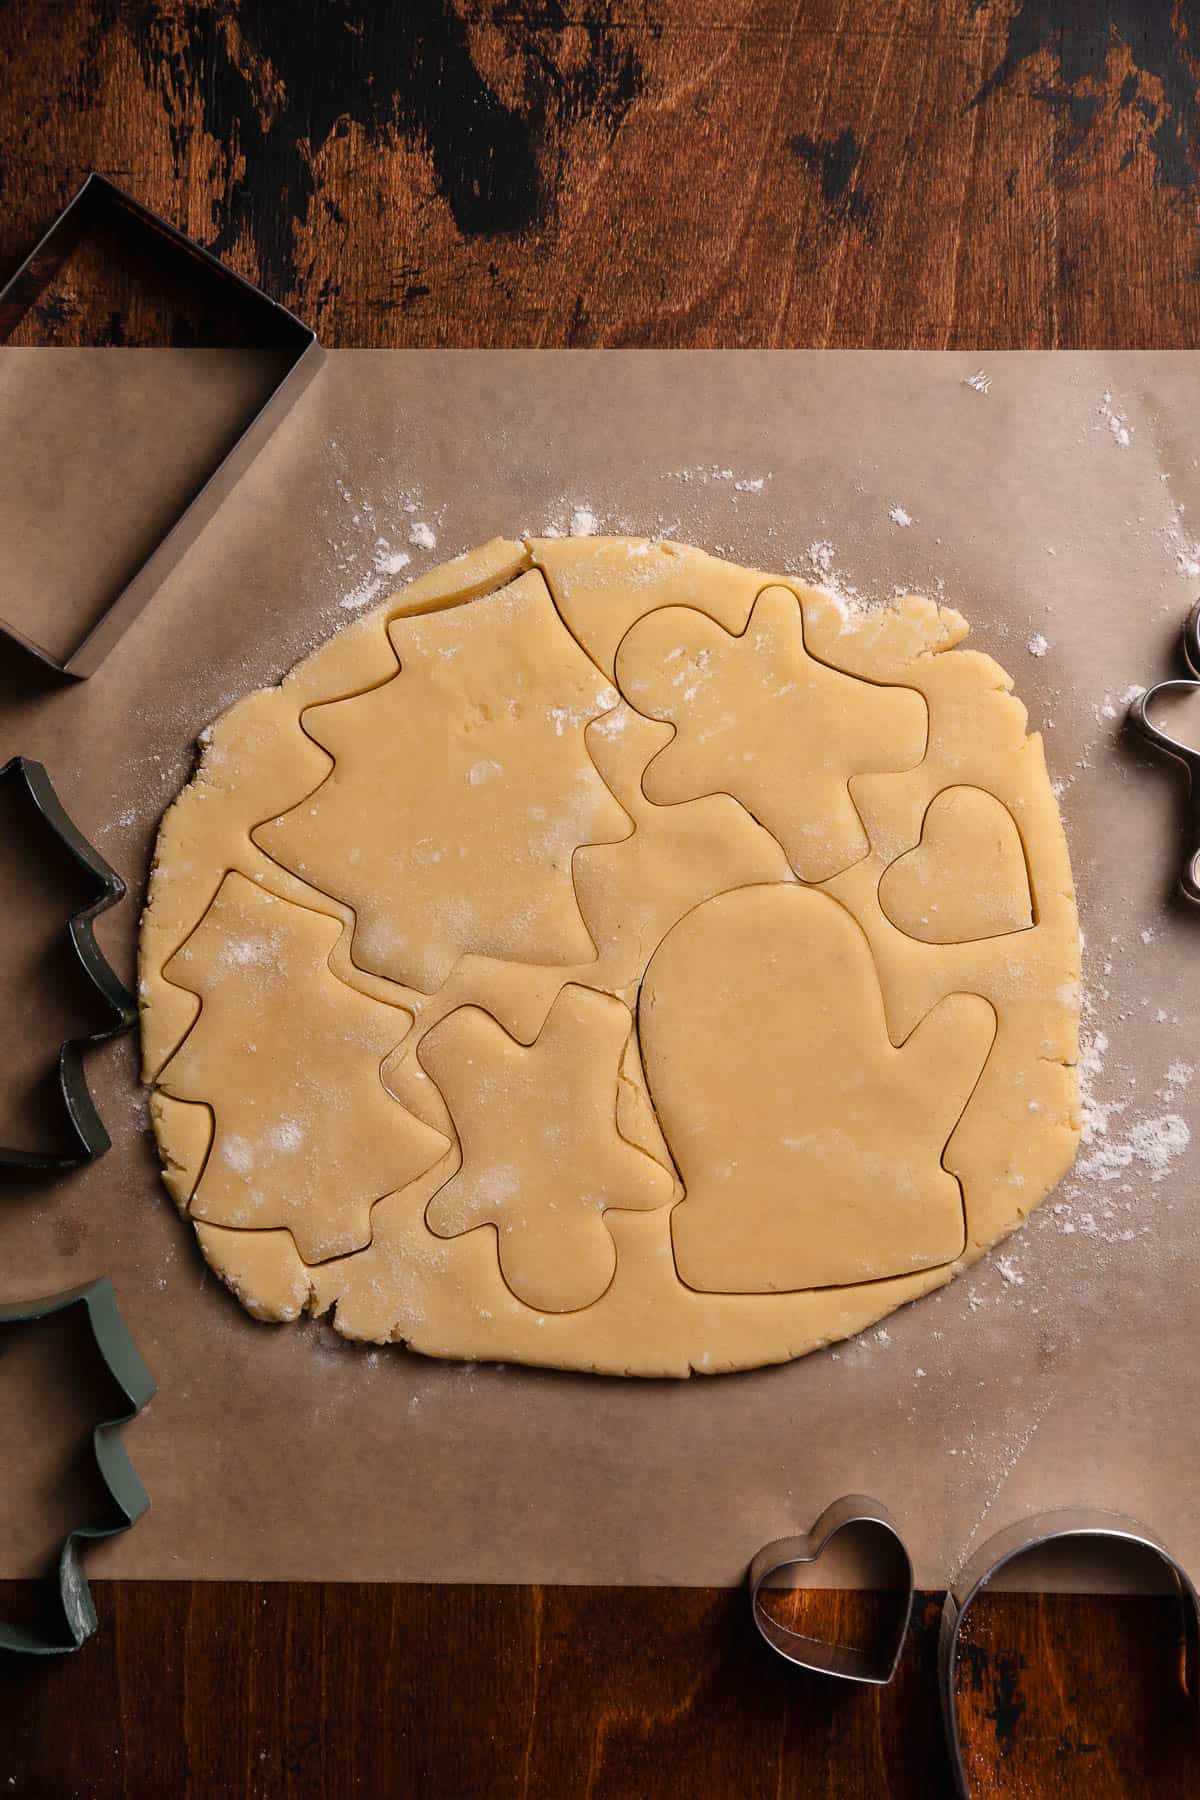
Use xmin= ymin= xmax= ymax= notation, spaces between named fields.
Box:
xmin=748 ymin=1494 xmax=912 ymax=1687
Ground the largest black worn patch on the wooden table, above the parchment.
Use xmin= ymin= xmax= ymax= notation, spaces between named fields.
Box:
xmin=120 ymin=0 xmax=642 ymax=288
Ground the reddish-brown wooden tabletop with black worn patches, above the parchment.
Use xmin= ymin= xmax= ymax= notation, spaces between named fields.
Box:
xmin=0 ymin=0 xmax=1200 ymax=349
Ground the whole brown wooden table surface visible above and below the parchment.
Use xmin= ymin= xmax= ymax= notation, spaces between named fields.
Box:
xmin=0 ymin=0 xmax=1200 ymax=1800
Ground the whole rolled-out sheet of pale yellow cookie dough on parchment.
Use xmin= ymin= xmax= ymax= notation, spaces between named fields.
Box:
xmin=140 ymin=538 xmax=1079 ymax=1375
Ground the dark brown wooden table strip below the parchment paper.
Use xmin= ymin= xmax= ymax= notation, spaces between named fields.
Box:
xmin=0 ymin=1582 xmax=1200 ymax=1800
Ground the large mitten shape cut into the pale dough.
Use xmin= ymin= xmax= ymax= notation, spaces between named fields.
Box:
xmin=639 ymin=886 xmax=995 ymax=1292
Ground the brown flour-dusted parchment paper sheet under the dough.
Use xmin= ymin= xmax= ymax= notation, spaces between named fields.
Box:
xmin=0 ymin=351 xmax=1200 ymax=1586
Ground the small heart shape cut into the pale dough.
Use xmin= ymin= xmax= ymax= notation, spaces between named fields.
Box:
xmin=880 ymin=787 xmax=1033 ymax=943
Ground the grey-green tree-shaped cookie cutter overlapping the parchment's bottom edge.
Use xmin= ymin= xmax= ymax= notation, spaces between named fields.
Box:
xmin=0 ymin=1276 xmax=155 ymax=1656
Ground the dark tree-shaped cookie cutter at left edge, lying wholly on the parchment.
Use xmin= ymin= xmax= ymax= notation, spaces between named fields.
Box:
xmin=0 ymin=756 xmax=137 ymax=1170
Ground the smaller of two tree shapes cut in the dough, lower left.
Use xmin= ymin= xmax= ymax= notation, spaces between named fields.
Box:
xmin=160 ymin=873 xmax=450 ymax=1264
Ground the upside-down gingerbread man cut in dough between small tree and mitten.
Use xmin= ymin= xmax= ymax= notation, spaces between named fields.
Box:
xmin=419 ymin=986 xmax=675 ymax=1312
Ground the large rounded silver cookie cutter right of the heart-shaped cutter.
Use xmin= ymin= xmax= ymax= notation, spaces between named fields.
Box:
xmin=937 ymin=1507 xmax=1200 ymax=1800
